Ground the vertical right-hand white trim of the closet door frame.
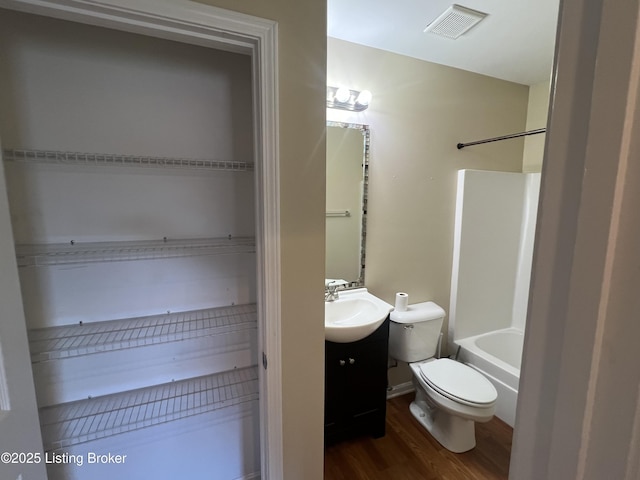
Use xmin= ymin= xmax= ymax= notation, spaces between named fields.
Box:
xmin=253 ymin=15 xmax=283 ymax=480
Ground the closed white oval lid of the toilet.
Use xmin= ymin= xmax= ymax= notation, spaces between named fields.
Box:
xmin=420 ymin=358 xmax=498 ymax=405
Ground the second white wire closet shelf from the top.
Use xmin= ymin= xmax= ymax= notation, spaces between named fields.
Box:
xmin=16 ymin=235 xmax=256 ymax=267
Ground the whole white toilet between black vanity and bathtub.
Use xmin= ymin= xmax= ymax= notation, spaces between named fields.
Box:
xmin=389 ymin=302 xmax=498 ymax=453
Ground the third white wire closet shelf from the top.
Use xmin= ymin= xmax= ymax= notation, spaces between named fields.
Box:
xmin=29 ymin=304 xmax=257 ymax=363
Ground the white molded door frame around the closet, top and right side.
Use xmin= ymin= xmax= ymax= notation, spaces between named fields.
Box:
xmin=0 ymin=0 xmax=283 ymax=480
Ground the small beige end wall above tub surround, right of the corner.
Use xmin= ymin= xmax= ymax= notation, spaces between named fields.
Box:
xmin=522 ymin=82 xmax=551 ymax=173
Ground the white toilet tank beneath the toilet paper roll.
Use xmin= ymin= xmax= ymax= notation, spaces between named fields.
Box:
xmin=389 ymin=302 xmax=445 ymax=363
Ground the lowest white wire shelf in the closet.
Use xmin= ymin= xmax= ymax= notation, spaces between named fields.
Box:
xmin=40 ymin=366 xmax=259 ymax=451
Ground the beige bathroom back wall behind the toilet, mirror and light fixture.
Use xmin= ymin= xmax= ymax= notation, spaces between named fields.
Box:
xmin=327 ymin=38 xmax=529 ymax=385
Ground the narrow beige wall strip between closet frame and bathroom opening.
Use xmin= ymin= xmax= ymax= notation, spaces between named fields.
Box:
xmin=202 ymin=0 xmax=327 ymax=480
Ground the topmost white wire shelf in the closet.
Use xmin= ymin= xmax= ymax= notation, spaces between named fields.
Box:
xmin=3 ymin=148 xmax=254 ymax=172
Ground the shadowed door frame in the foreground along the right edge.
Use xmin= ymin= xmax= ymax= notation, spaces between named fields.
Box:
xmin=509 ymin=0 xmax=640 ymax=480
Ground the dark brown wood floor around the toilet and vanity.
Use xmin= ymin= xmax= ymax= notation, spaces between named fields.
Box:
xmin=324 ymin=394 xmax=513 ymax=480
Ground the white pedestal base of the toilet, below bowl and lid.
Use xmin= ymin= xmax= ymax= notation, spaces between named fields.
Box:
xmin=409 ymin=388 xmax=476 ymax=453
